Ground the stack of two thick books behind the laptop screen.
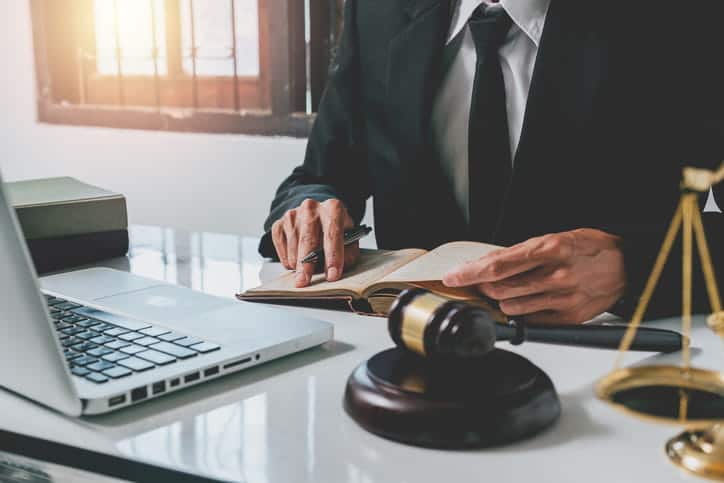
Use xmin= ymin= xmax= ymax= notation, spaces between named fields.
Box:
xmin=7 ymin=178 xmax=128 ymax=273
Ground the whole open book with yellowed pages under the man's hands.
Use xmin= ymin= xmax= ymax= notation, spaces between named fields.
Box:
xmin=237 ymin=242 xmax=505 ymax=321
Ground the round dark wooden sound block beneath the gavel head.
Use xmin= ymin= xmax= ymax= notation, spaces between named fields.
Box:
xmin=344 ymin=349 xmax=561 ymax=449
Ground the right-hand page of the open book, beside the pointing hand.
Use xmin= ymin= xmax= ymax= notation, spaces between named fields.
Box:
xmin=381 ymin=241 xmax=501 ymax=283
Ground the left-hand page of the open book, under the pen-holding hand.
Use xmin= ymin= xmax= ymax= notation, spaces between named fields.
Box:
xmin=243 ymin=249 xmax=425 ymax=297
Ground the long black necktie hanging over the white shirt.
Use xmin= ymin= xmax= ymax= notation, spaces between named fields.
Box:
xmin=468 ymin=5 xmax=512 ymax=242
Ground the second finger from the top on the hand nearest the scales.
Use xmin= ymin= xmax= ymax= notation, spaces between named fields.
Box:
xmin=478 ymin=266 xmax=576 ymax=300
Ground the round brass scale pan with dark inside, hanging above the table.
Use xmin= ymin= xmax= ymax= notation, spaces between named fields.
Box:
xmin=596 ymin=366 xmax=724 ymax=429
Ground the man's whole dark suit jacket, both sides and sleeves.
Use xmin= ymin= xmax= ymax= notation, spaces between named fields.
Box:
xmin=260 ymin=0 xmax=724 ymax=322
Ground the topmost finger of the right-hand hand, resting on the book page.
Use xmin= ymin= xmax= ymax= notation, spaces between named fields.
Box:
xmin=443 ymin=233 xmax=574 ymax=287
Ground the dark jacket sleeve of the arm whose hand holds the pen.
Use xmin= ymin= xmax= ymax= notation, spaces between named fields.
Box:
xmin=259 ymin=0 xmax=370 ymax=258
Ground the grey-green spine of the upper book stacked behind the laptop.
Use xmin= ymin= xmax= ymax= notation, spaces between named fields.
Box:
xmin=16 ymin=196 xmax=128 ymax=240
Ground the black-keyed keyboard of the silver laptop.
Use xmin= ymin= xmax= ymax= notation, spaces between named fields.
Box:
xmin=45 ymin=295 xmax=220 ymax=384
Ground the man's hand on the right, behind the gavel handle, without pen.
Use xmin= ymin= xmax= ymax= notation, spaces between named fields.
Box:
xmin=443 ymin=228 xmax=626 ymax=324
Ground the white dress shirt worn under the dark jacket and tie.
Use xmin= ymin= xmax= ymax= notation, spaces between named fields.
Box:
xmin=432 ymin=0 xmax=550 ymax=221
